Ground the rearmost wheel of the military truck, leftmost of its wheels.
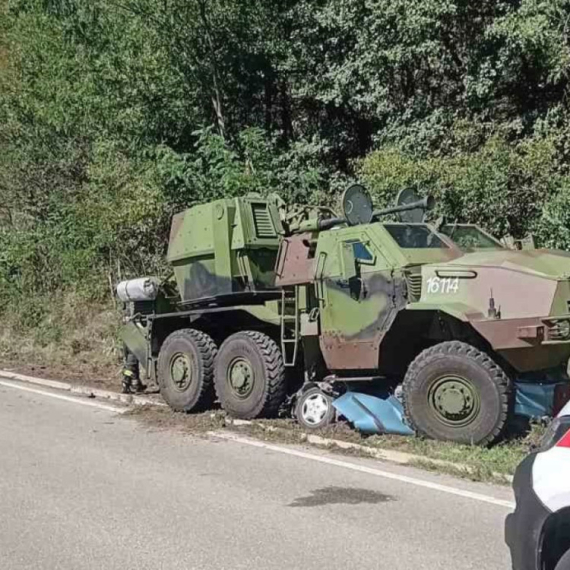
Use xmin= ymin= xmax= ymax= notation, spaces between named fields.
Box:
xmin=158 ymin=329 xmax=217 ymax=412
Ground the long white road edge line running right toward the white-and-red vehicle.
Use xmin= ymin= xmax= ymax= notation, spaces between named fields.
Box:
xmin=209 ymin=431 xmax=515 ymax=509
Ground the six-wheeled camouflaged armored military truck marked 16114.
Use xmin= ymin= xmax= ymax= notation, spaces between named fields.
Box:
xmin=116 ymin=185 xmax=570 ymax=444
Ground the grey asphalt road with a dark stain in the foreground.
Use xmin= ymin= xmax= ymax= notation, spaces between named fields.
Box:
xmin=0 ymin=378 xmax=512 ymax=570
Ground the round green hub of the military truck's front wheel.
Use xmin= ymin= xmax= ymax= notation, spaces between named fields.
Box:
xmin=429 ymin=376 xmax=481 ymax=427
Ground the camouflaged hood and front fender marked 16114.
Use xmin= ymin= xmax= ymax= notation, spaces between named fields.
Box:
xmin=408 ymin=249 xmax=570 ymax=372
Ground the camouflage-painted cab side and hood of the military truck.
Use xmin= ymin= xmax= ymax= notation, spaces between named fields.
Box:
xmin=304 ymin=223 xmax=570 ymax=372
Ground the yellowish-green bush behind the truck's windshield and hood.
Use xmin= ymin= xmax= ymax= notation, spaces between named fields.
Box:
xmin=358 ymin=126 xmax=570 ymax=244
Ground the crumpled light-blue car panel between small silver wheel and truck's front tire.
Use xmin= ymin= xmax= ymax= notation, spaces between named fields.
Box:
xmin=333 ymin=392 xmax=414 ymax=435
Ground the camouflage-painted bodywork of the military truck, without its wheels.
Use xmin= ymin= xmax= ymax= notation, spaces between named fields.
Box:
xmin=125 ymin=196 xmax=570 ymax=384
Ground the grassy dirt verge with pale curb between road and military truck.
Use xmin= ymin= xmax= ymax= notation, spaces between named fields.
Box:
xmin=0 ymin=363 xmax=544 ymax=484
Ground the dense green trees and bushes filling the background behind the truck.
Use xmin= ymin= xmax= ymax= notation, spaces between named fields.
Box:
xmin=0 ymin=0 xmax=570 ymax=330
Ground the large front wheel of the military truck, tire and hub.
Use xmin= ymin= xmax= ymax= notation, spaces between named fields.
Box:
xmin=403 ymin=341 xmax=511 ymax=445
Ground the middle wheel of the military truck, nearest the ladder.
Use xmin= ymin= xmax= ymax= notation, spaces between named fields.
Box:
xmin=214 ymin=331 xmax=286 ymax=419
